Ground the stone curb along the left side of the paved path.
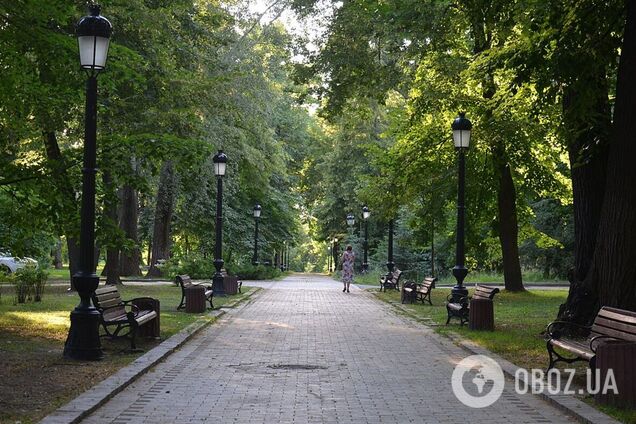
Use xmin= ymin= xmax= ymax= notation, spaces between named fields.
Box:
xmin=40 ymin=287 xmax=261 ymax=424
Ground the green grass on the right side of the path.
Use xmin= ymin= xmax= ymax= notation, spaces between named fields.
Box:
xmin=370 ymin=287 xmax=636 ymax=423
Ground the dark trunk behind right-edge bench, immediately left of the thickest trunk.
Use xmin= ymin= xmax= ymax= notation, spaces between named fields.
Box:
xmin=558 ymin=60 xmax=611 ymax=325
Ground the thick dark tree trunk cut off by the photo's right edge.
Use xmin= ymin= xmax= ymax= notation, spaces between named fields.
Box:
xmin=585 ymin=1 xmax=636 ymax=315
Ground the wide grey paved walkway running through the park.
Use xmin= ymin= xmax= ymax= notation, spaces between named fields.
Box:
xmin=83 ymin=275 xmax=572 ymax=424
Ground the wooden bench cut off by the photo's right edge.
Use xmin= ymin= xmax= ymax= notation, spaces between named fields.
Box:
xmin=546 ymin=306 xmax=636 ymax=375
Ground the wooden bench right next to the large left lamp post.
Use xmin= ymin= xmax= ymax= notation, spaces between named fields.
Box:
xmin=92 ymin=285 xmax=159 ymax=350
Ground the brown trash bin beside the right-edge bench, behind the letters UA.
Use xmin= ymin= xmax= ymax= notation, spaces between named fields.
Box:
xmin=594 ymin=342 xmax=636 ymax=408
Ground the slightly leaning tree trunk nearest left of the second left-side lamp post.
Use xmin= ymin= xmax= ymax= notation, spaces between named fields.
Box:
xmin=147 ymin=161 xmax=176 ymax=277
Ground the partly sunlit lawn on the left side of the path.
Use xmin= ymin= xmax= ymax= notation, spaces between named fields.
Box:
xmin=0 ymin=283 xmax=249 ymax=423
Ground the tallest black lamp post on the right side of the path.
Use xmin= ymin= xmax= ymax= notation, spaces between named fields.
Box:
xmin=451 ymin=112 xmax=473 ymax=301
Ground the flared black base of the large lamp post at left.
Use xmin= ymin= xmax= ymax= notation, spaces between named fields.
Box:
xmin=64 ymin=306 xmax=104 ymax=361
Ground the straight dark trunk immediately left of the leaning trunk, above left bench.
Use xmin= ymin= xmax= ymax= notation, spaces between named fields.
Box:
xmin=119 ymin=186 xmax=141 ymax=276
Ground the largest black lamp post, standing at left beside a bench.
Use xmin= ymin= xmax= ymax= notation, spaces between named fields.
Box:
xmin=64 ymin=4 xmax=113 ymax=360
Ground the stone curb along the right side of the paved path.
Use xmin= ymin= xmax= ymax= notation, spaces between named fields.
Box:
xmin=373 ymin=295 xmax=621 ymax=424
